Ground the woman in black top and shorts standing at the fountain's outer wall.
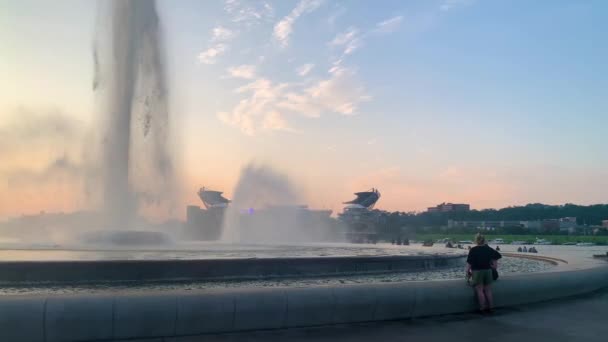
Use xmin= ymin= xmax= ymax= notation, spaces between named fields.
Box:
xmin=467 ymin=234 xmax=502 ymax=313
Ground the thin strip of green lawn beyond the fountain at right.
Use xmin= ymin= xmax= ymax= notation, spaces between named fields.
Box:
xmin=415 ymin=233 xmax=608 ymax=245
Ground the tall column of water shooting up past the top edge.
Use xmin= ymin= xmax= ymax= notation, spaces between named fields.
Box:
xmin=93 ymin=0 xmax=173 ymax=228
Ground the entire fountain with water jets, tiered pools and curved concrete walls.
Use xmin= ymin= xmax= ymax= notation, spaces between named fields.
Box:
xmin=0 ymin=0 xmax=608 ymax=341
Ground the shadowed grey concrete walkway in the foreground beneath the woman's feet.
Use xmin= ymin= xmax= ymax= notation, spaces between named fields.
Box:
xmin=166 ymin=291 xmax=608 ymax=342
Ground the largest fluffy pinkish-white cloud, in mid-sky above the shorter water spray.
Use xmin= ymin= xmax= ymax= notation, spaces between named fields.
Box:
xmin=217 ymin=66 xmax=370 ymax=135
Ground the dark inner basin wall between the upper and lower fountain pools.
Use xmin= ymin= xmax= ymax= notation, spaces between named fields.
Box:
xmin=0 ymin=255 xmax=465 ymax=285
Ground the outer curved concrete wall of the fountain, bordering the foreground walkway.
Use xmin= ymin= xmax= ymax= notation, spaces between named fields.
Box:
xmin=0 ymin=266 xmax=608 ymax=342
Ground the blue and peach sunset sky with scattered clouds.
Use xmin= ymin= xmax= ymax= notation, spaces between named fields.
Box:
xmin=0 ymin=0 xmax=608 ymax=218
